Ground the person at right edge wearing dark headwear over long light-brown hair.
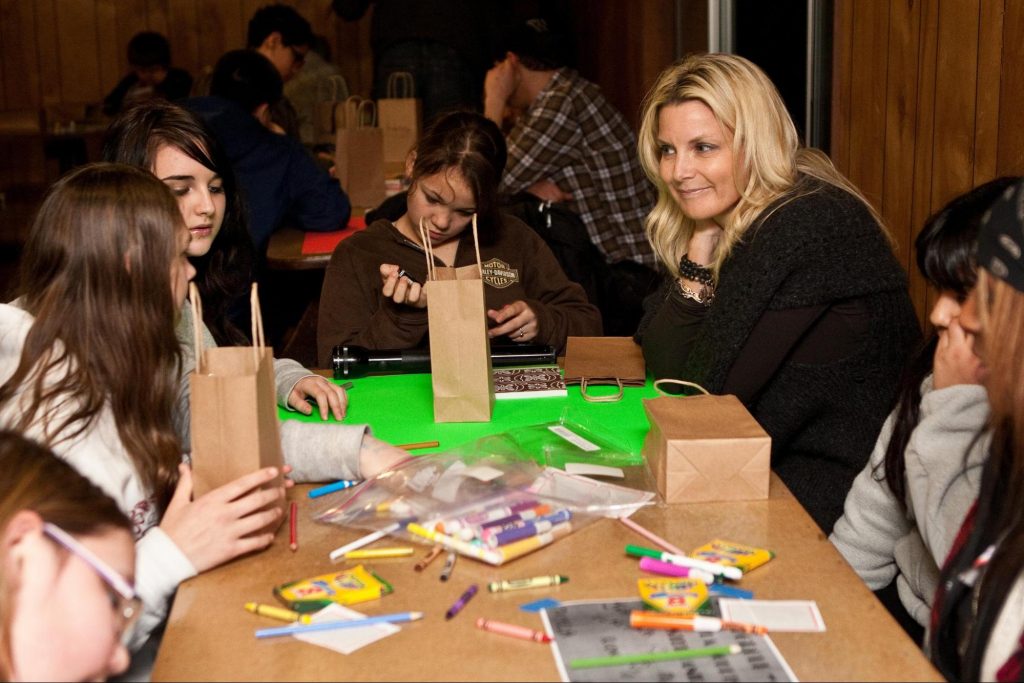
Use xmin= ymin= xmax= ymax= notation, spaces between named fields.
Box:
xmin=928 ymin=182 xmax=1024 ymax=681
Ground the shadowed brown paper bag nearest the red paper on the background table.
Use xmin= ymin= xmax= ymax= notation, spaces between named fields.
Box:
xmin=334 ymin=97 xmax=385 ymax=209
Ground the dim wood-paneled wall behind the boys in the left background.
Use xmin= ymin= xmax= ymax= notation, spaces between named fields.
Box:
xmin=0 ymin=0 xmax=372 ymax=111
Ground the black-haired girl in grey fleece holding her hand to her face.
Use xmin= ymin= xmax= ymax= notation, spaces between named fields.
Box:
xmin=830 ymin=178 xmax=1016 ymax=644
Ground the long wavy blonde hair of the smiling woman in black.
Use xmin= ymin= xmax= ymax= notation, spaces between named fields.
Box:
xmin=638 ymin=54 xmax=885 ymax=276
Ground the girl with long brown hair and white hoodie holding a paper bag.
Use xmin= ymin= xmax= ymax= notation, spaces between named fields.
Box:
xmin=0 ymin=164 xmax=284 ymax=660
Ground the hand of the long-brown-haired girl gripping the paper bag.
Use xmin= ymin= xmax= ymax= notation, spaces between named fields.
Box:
xmin=160 ymin=464 xmax=285 ymax=572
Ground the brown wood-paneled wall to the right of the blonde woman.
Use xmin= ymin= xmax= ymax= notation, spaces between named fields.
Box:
xmin=831 ymin=0 xmax=1024 ymax=322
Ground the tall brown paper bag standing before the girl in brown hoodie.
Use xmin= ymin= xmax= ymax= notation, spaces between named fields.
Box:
xmin=420 ymin=214 xmax=495 ymax=422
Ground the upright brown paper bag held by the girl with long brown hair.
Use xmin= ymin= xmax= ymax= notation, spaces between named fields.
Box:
xmin=188 ymin=284 xmax=285 ymax=507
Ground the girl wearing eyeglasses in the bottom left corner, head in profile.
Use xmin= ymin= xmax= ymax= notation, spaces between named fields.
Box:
xmin=0 ymin=431 xmax=140 ymax=681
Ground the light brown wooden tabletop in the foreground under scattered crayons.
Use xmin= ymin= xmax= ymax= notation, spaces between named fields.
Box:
xmin=153 ymin=474 xmax=942 ymax=681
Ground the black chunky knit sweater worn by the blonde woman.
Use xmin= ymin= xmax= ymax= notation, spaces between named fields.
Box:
xmin=637 ymin=179 xmax=921 ymax=533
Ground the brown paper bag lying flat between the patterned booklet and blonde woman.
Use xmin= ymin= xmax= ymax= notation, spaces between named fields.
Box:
xmin=565 ymin=337 xmax=647 ymax=402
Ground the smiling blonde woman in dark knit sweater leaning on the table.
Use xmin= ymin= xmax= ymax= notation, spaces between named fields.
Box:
xmin=637 ymin=54 xmax=921 ymax=531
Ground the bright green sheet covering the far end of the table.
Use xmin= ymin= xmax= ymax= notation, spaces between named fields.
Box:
xmin=279 ymin=374 xmax=657 ymax=455
